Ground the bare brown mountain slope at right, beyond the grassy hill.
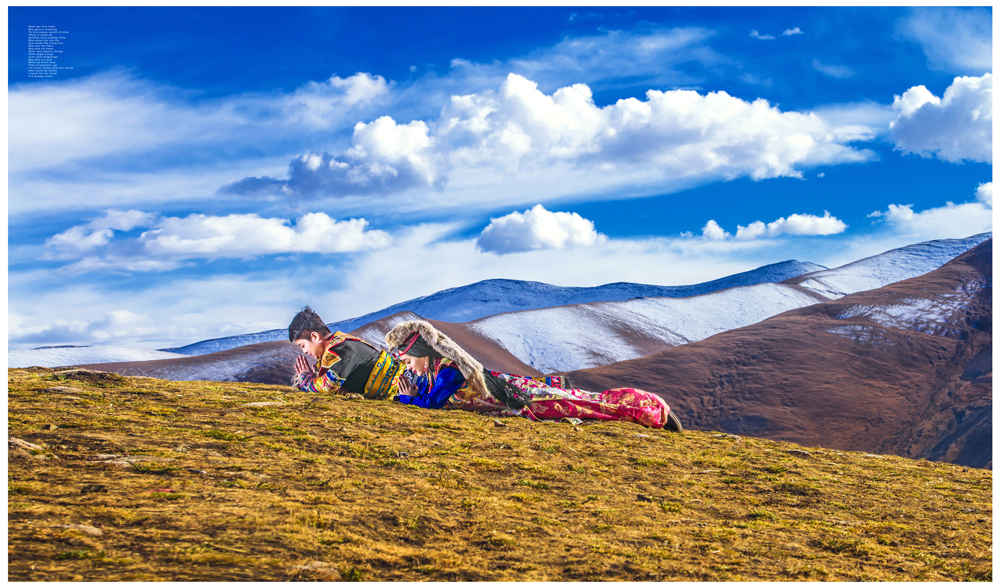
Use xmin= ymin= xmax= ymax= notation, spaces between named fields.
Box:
xmin=569 ymin=240 xmax=993 ymax=466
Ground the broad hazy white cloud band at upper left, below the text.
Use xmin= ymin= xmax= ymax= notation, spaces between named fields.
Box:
xmin=8 ymin=73 xmax=389 ymax=173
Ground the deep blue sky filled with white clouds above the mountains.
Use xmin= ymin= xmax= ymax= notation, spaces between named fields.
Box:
xmin=8 ymin=7 xmax=992 ymax=349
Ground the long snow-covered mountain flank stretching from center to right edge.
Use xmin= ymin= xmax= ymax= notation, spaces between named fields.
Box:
xmin=456 ymin=233 xmax=990 ymax=373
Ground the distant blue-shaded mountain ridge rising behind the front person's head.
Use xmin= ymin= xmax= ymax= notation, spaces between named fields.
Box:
xmin=164 ymin=260 xmax=826 ymax=355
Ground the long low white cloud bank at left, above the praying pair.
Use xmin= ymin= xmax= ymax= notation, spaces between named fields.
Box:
xmin=46 ymin=211 xmax=391 ymax=273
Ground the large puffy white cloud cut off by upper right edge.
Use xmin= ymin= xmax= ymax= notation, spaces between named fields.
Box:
xmin=889 ymin=73 xmax=993 ymax=163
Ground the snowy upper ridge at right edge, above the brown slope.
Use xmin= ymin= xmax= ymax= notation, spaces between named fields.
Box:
xmin=786 ymin=233 xmax=993 ymax=300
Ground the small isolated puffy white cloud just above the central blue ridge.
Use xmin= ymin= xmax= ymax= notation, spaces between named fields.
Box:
xmin=476 ymin=204 xmax=607 ymax=255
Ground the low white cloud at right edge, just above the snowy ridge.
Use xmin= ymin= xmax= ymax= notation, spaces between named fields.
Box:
xmin=868 ymin=182 xmax=993 ymax=241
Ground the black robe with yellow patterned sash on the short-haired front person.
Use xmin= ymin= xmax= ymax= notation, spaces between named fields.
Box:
xmin=292 ymin=331 xmax=405 ymax=400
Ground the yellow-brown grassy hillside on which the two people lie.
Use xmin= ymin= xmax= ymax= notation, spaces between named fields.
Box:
xmin=8 ymin=369 xmax=992 ymax=581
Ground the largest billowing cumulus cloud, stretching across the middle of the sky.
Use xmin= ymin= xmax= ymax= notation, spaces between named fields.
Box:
xmin=234 ymin=74 xmax=873 ymax=201
